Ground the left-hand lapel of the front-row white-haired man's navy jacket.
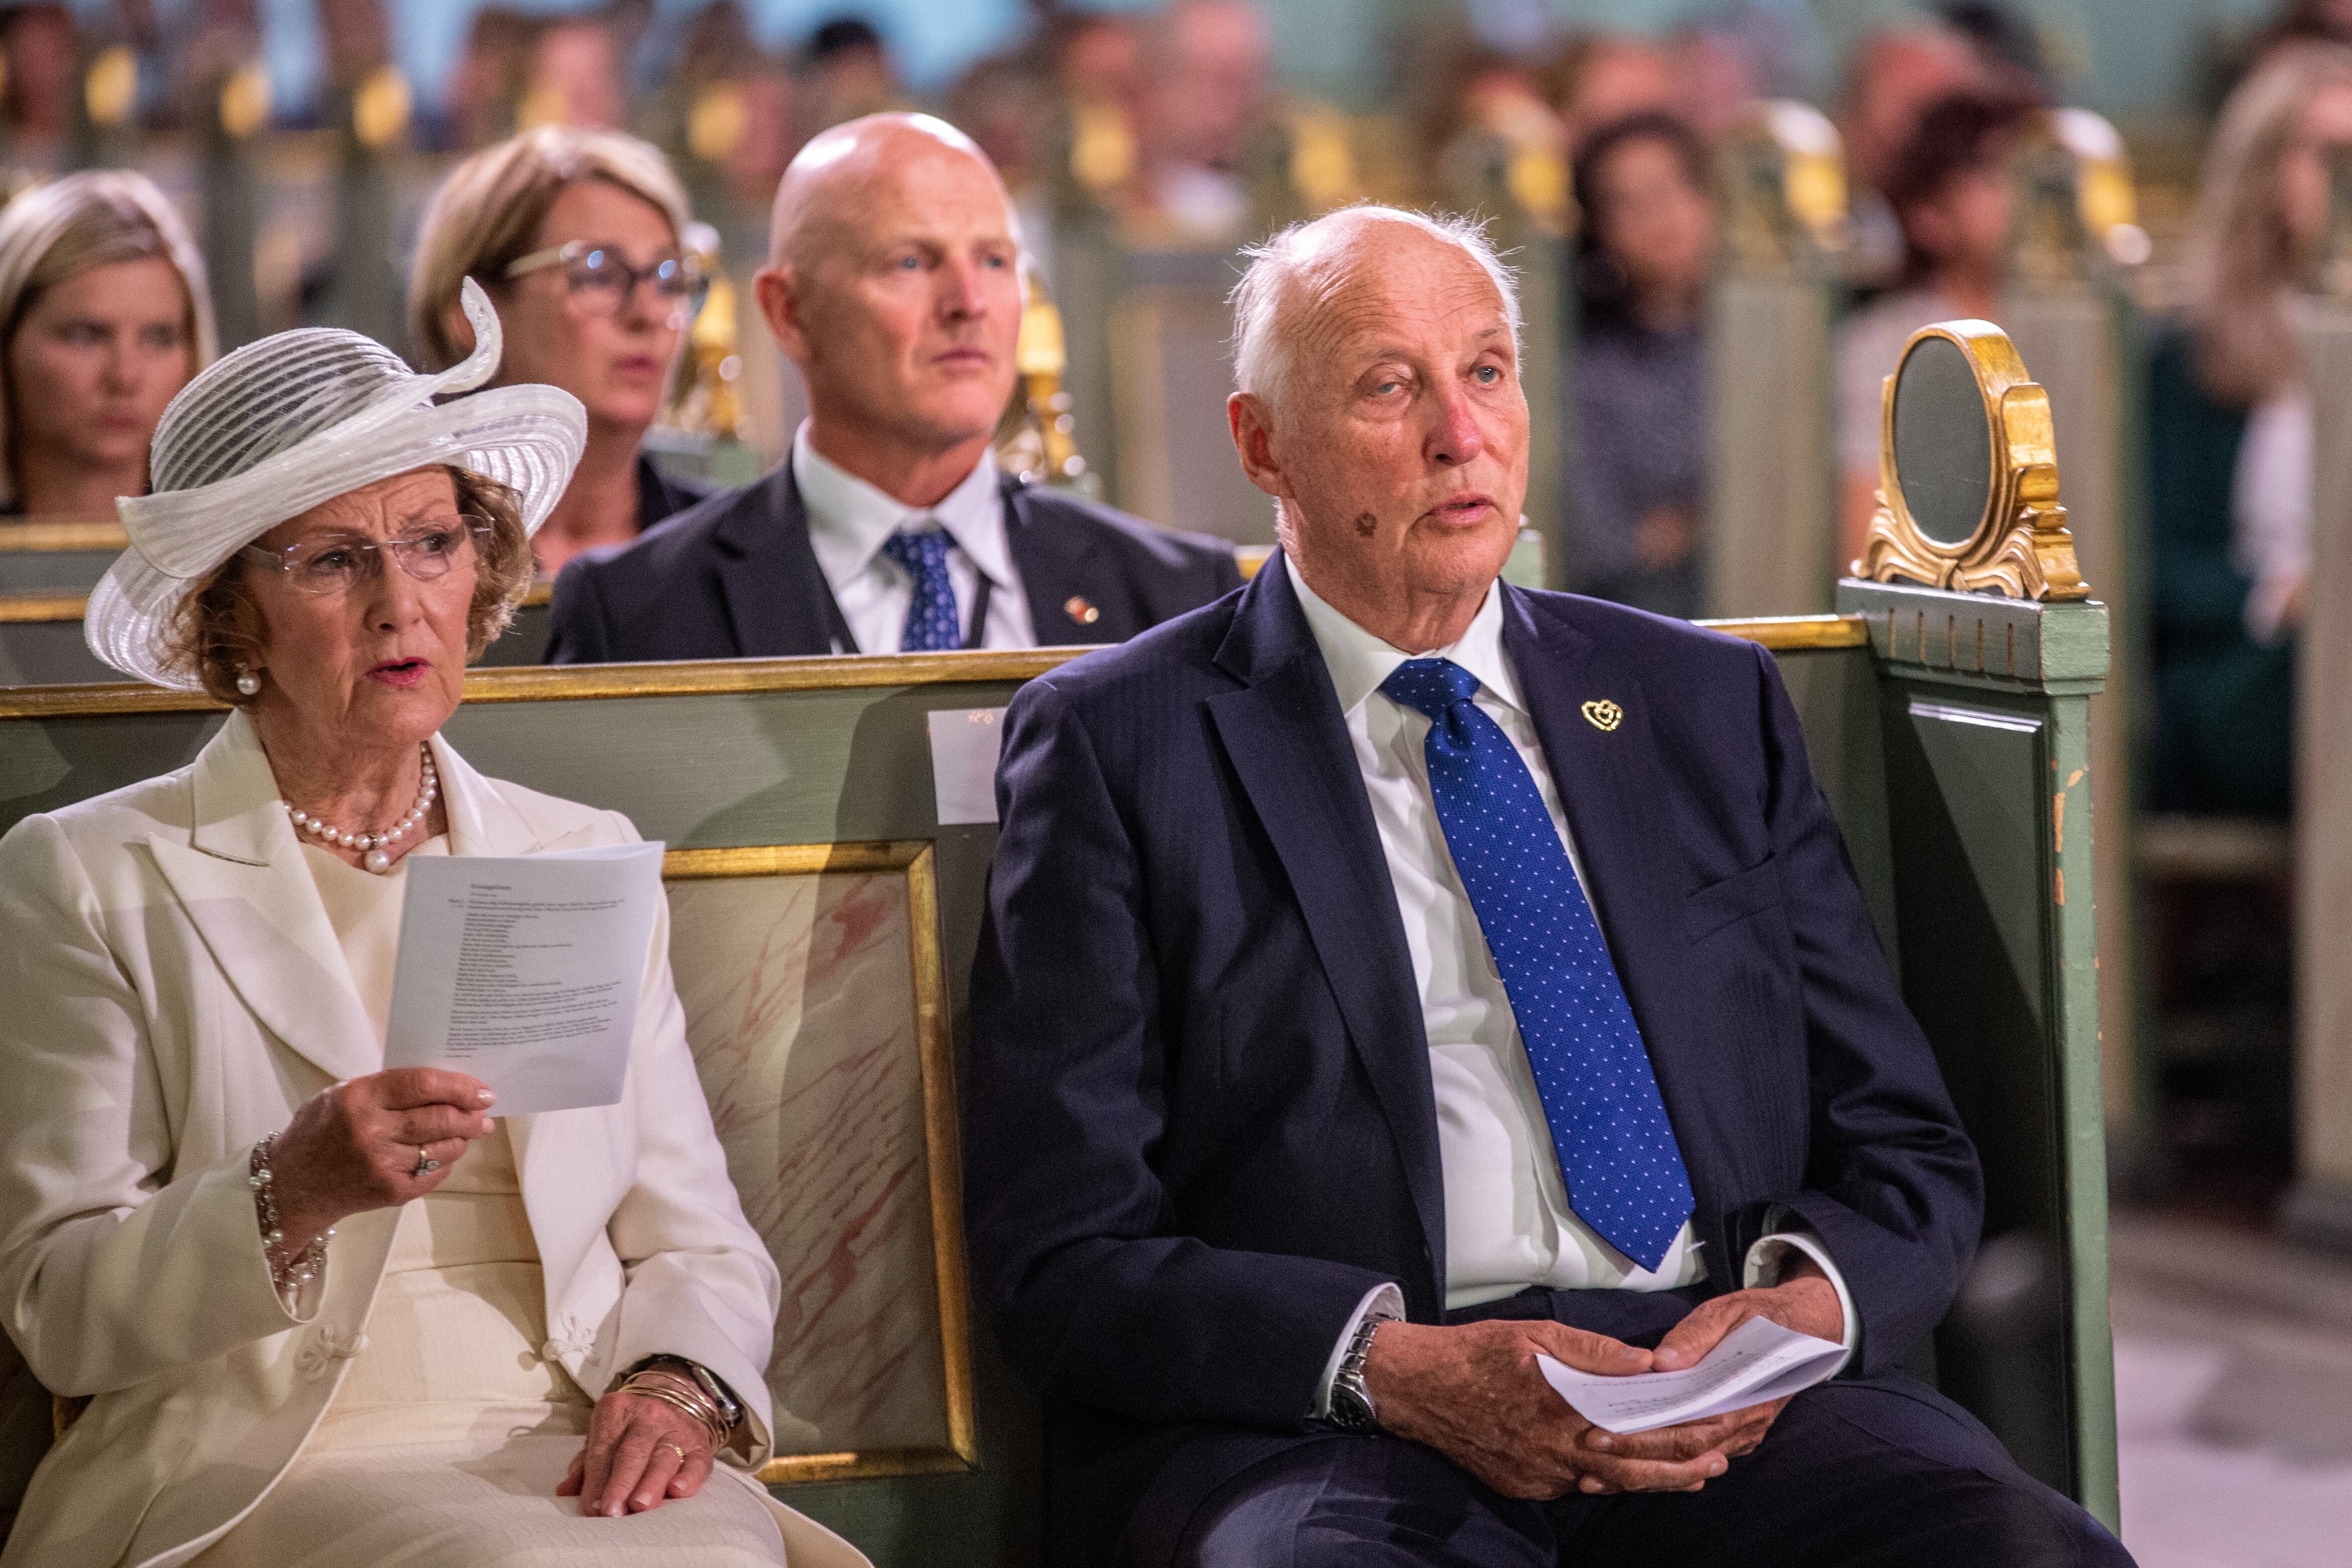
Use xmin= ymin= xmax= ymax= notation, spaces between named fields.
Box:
xmin=1213 ymin=555 xmax=1446 ymax=1312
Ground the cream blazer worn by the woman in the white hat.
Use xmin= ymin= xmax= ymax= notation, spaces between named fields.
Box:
xmin=0 ymin=712 xmax=865 ymax=1568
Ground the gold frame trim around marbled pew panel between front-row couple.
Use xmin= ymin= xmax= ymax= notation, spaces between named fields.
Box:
xmin=661 ymin=839 xmax=981 ymax=1483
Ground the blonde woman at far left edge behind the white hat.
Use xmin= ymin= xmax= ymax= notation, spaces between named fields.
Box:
xmin=0 ymin=169 xmax=214 ymax=517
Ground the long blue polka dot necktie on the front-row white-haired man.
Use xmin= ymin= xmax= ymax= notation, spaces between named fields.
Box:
xmin=1381 ymin=658 xmax=1691 ymax=1270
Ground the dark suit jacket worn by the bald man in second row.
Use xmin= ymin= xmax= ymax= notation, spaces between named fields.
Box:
xmin=548 ymin=463 xmax=1242 ymax=665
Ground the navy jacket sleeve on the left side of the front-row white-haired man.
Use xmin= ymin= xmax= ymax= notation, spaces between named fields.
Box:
xmin=967 ymin=677 xmax=1381 ymax=1429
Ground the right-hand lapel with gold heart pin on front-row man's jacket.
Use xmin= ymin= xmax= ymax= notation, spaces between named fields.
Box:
xmin=1503 ymin=583 xmax=1736 ymax=1284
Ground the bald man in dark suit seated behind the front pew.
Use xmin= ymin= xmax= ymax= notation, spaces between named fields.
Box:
xmin=548 ymin=115 xmax=1242 ymax=663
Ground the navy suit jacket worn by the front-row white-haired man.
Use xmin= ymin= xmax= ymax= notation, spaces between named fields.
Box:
xmin=964 ymin=562 xmax=1983 ymax=1563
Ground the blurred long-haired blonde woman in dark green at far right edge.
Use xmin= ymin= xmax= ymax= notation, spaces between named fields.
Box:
xmin=2148 ymin=45 xmax=2352 ymax=816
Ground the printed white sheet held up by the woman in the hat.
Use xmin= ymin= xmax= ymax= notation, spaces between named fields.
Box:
xmin=383 ymin=844 xmax=661 ymax=1116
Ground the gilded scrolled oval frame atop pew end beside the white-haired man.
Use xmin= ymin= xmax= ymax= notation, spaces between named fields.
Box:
xmin=1853 ymin=320 xmax=2091 ymax=600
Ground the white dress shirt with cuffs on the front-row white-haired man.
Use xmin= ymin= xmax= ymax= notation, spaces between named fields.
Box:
xmin=1284 ymin=557 xmax=1856 ymax=1408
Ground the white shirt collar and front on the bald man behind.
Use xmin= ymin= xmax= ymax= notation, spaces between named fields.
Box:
xmin=793 ymin=421 xmax=1037 ymax=653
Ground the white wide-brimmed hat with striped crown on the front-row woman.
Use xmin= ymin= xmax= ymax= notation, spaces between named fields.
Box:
xmin=82 ymin=277 xmax=588 ymax=691
